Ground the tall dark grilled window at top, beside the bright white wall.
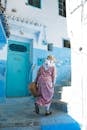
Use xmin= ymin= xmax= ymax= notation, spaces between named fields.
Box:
xmin=58 ymin=0 xmax=66 ymax=17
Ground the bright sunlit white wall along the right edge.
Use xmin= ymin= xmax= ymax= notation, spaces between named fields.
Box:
xmin=67 ymin=0 xmax=87 ymax=124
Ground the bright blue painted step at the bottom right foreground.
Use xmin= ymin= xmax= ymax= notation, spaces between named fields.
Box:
xmin=41 ymin=113 xmax=81 ymax=130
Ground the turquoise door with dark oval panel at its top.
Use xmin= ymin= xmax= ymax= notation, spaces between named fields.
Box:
xmin=6 ymin=41 xmax=32 ymax=97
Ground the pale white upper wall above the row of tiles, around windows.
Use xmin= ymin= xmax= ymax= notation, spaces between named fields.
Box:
xmin=7 ymin=0 xmax=68 ymax=47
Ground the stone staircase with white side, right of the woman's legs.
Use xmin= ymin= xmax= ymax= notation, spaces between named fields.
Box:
xmin=53 ymin=85 xmax=71 ymax=113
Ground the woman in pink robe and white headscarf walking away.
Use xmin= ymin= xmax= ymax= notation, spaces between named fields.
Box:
xmin=35 ymin=55 xmax=56 ymax=115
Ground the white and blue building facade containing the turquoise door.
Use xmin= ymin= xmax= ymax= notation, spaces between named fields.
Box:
xmin=0 ymin=0 xmax=71 ymax=97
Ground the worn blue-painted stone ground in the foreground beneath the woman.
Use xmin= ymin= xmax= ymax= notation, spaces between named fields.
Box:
xmin=0 ymin=98 xmax=80 ymax=130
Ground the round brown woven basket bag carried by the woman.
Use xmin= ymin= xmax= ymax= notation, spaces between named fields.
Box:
xmin=29 ymin=82 xmax=38 ymax=97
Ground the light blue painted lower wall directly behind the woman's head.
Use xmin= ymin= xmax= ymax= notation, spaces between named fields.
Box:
xmin=32 ymin=47 xmax=71 ymax=86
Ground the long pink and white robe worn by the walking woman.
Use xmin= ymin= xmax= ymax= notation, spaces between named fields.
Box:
xmin=36 ymin=61 xmax=56 ymax=106
